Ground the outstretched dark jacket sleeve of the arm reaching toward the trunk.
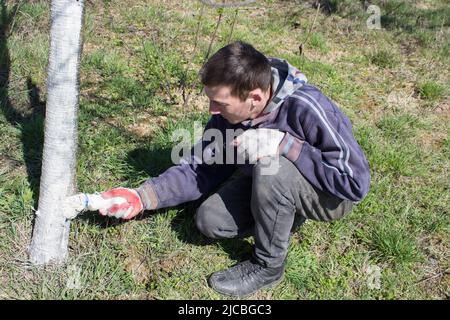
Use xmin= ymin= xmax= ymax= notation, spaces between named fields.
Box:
xmin=136 ymin=117 xmax=236 ymax=210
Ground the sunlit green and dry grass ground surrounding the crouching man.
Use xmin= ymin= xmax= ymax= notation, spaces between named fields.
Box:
xmin=0 ymin=0 xmax=450 ymax=299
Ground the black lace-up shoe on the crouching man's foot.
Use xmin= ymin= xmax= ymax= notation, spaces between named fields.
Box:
xmin=208 ymin=260 xmax=284 ymax=297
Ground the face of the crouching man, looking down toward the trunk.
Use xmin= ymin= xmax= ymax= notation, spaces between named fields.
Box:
xmin=205 ymin=86 xmax=251 ymax=124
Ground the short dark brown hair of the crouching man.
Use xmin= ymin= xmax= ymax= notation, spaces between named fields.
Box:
xmin=200 ymin=41 xmax=272 ymax=100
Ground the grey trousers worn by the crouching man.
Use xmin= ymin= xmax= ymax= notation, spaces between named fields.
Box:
xmin=195 ymin=156 xmax=353 ymax=267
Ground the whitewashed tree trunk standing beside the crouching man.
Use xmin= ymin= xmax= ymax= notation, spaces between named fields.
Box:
xmin=29 ymin=0 xmax=84 ymax=265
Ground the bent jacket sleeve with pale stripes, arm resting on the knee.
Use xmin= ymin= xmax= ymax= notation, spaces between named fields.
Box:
xmin=280 ymin=91 xmax=370 ymax=202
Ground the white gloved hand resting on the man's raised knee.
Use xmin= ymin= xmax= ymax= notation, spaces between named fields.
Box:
xmin=233 ymin=128 xmax=285 ymax=163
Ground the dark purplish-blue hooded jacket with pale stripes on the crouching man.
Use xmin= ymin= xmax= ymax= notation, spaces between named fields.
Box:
xmin=136 ymin=58 xmax=370 ymax=209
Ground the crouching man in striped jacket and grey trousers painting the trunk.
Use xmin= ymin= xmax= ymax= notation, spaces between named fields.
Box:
xmin=94 ymin=41 xmax=370 ymax=297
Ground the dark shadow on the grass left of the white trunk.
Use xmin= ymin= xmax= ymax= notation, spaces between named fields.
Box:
xmin=0 ymin=1 xmax=45 ymax=207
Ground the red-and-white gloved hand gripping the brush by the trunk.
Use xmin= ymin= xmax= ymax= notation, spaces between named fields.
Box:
xmin=99 ymin=188 xmax=144 ymax=220
